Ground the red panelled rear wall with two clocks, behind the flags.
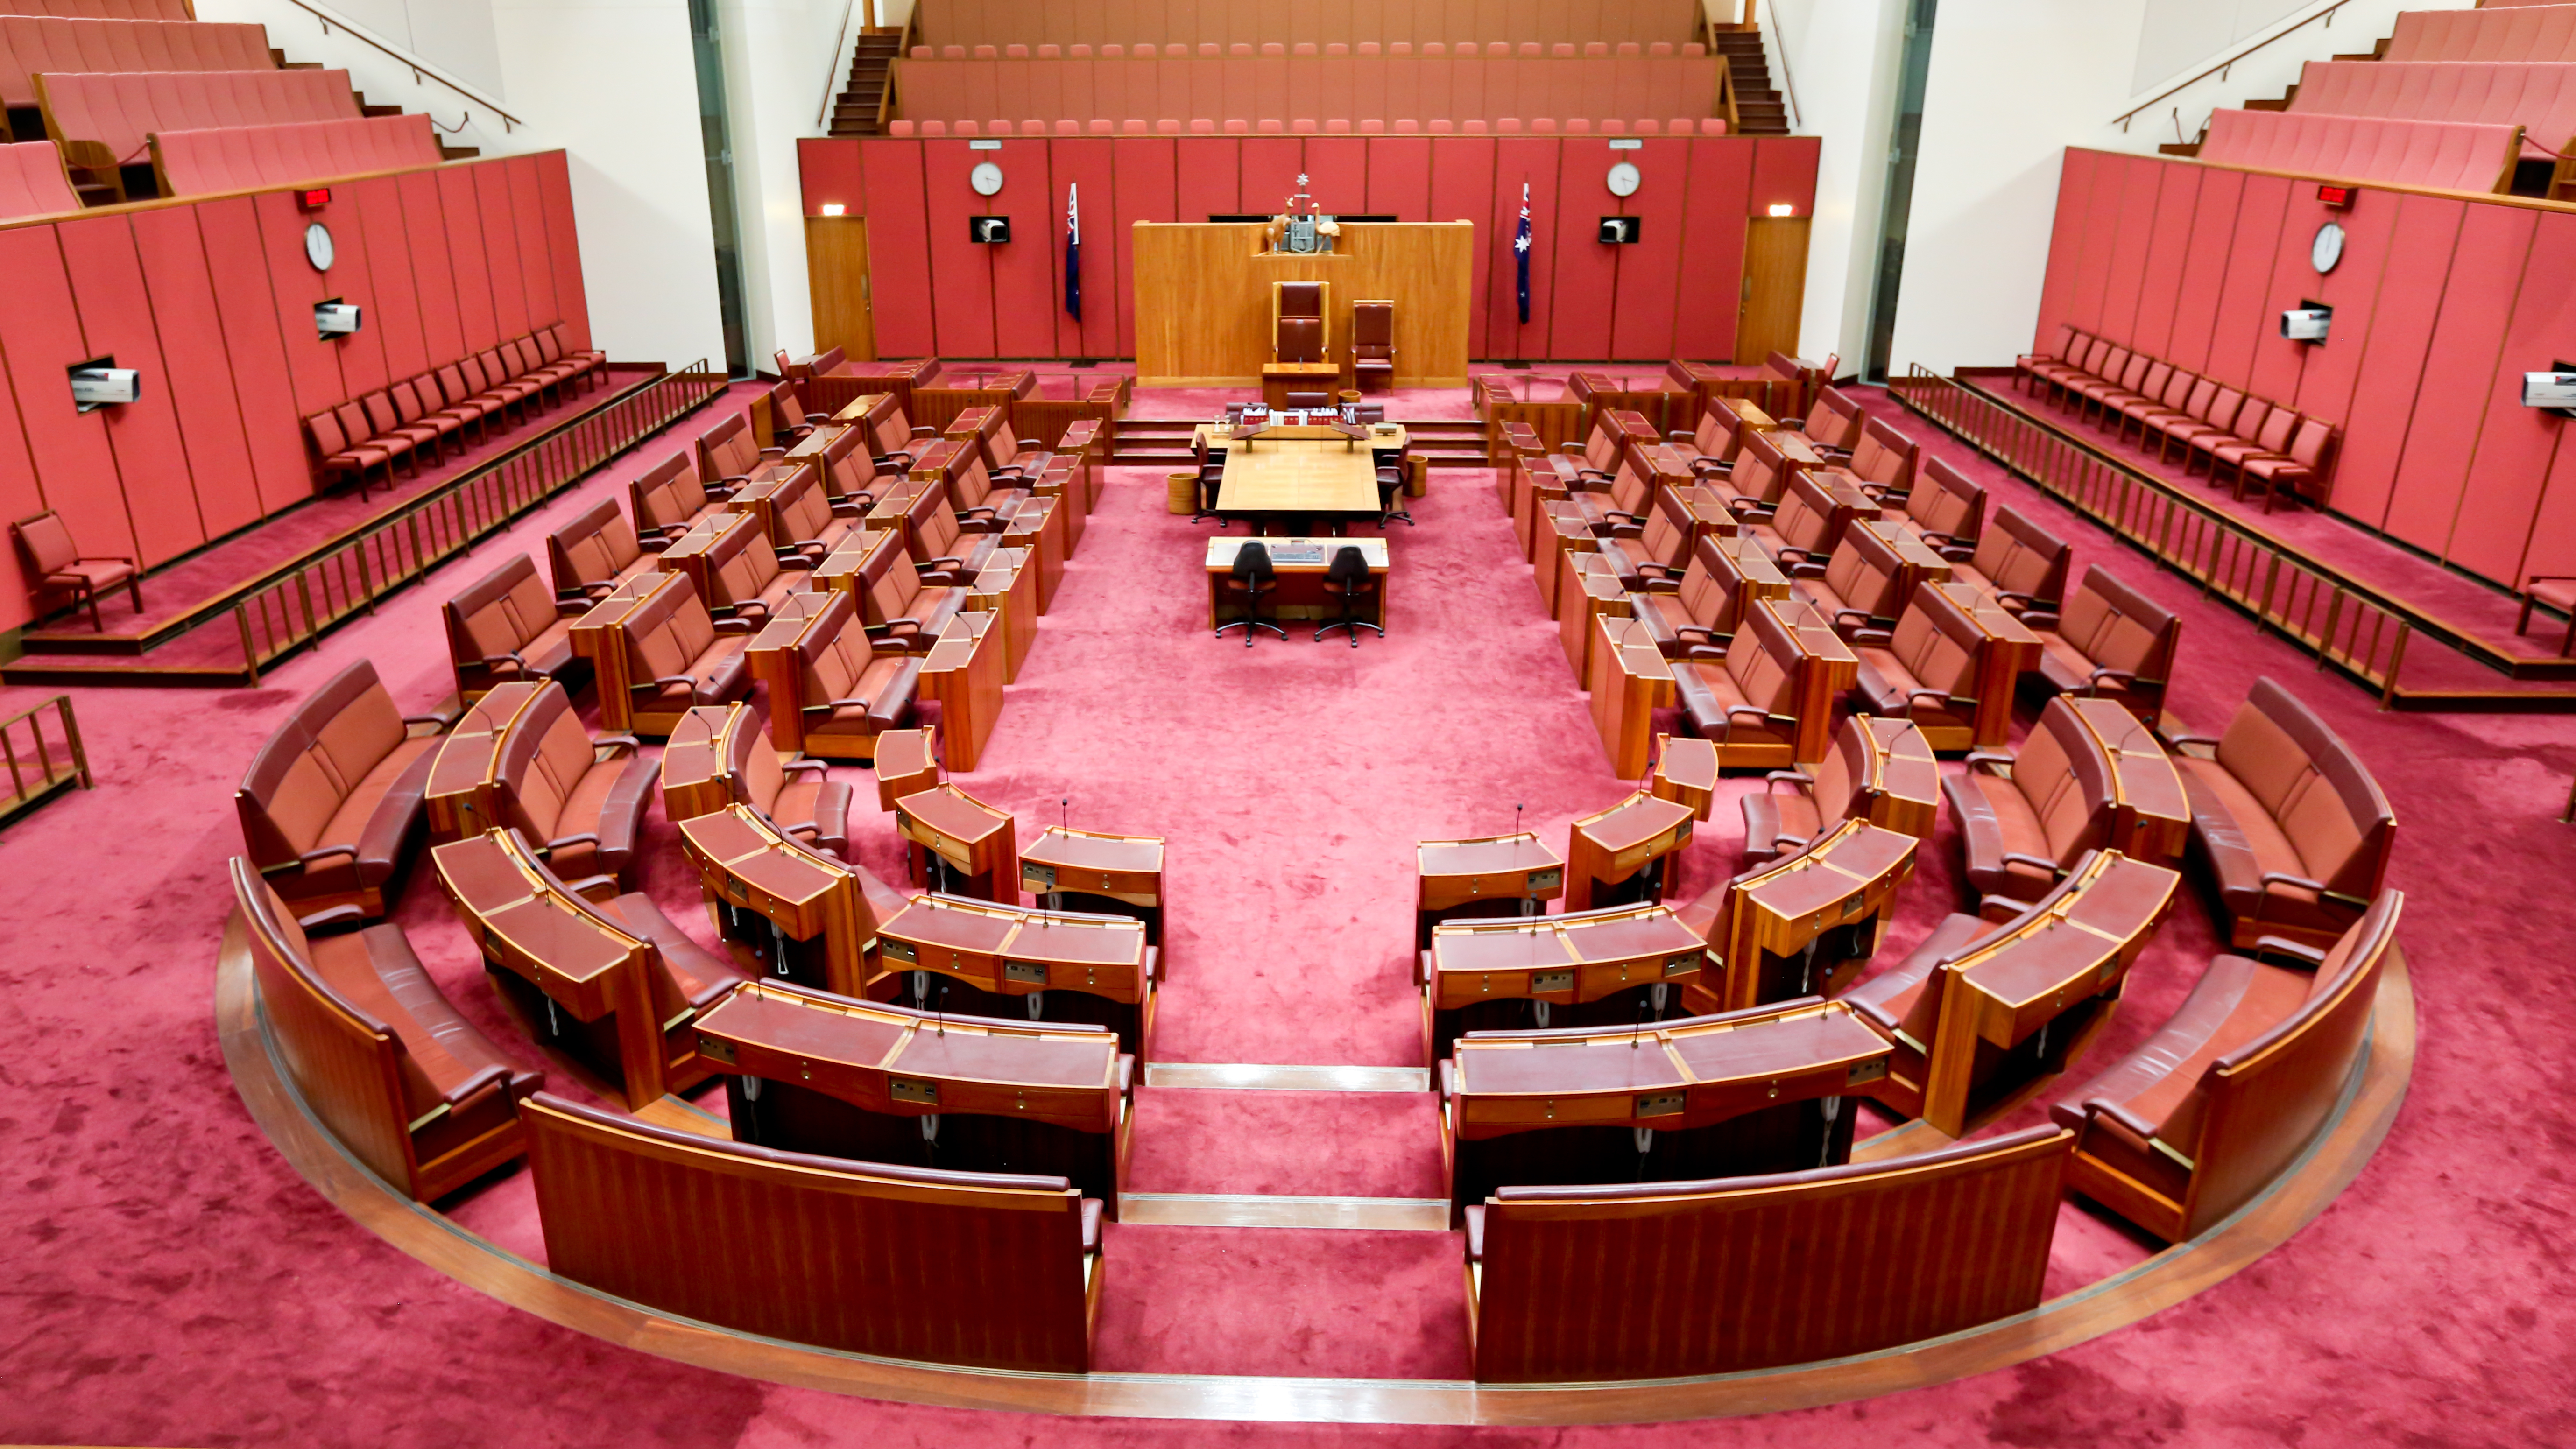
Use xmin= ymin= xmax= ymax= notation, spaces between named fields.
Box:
xmin=798 ymin=136 xmax=1819 ymax=360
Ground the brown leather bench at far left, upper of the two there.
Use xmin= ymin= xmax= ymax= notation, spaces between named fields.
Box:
xmin=234 ymin=659 xmax=443 ymax=916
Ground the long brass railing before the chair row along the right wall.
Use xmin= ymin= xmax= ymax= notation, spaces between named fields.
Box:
xmin=1888 ymin=363 xmax=2414 ymax=708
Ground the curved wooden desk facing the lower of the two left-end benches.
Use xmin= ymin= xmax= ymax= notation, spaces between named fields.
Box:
xmin=430 ymin=831 xmax=664 ymax=1109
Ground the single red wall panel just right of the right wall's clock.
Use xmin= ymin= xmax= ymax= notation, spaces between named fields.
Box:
xmin=2331 ymin=196 xmax=2468 ymax=528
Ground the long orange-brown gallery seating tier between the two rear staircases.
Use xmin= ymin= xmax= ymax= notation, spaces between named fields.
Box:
xmin=896 ymin=41 xmax=1718 ymax=134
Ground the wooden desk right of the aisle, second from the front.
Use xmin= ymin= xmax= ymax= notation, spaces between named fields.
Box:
xmin=1414 ymin=906 xmax=1708 ymax=1063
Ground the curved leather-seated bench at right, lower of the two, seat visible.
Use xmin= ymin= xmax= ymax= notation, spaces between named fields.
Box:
xmin=2048 ymin=891 xmax=2406 ymax=1243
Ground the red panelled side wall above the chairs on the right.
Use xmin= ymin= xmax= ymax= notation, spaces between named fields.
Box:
xmin=2038 ymin=149 xmax=2576 ymax=584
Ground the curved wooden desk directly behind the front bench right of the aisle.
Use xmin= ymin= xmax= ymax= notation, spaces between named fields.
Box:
xmin=1440 ymin=999 xmax=1893 ymax=1223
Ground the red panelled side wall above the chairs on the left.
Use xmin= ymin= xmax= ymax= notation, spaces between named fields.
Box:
xmin=0 ymin=152 xmax=590 ymax=628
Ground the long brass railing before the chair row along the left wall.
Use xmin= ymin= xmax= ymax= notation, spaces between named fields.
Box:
xmin=232 ymin=358 xmax=727 ymax=685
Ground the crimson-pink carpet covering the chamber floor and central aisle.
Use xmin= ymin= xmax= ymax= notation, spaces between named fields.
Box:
xmin=0 ymin=380 xmax=2576 ymax=1449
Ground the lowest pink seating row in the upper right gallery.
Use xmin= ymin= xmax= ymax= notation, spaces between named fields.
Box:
xmin=2200 ymin=106 xmax=2522 ymax=190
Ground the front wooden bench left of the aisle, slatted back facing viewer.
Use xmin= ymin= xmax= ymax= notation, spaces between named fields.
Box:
xmin=523 ymin=1094 xmax=1102 ymax=1374
